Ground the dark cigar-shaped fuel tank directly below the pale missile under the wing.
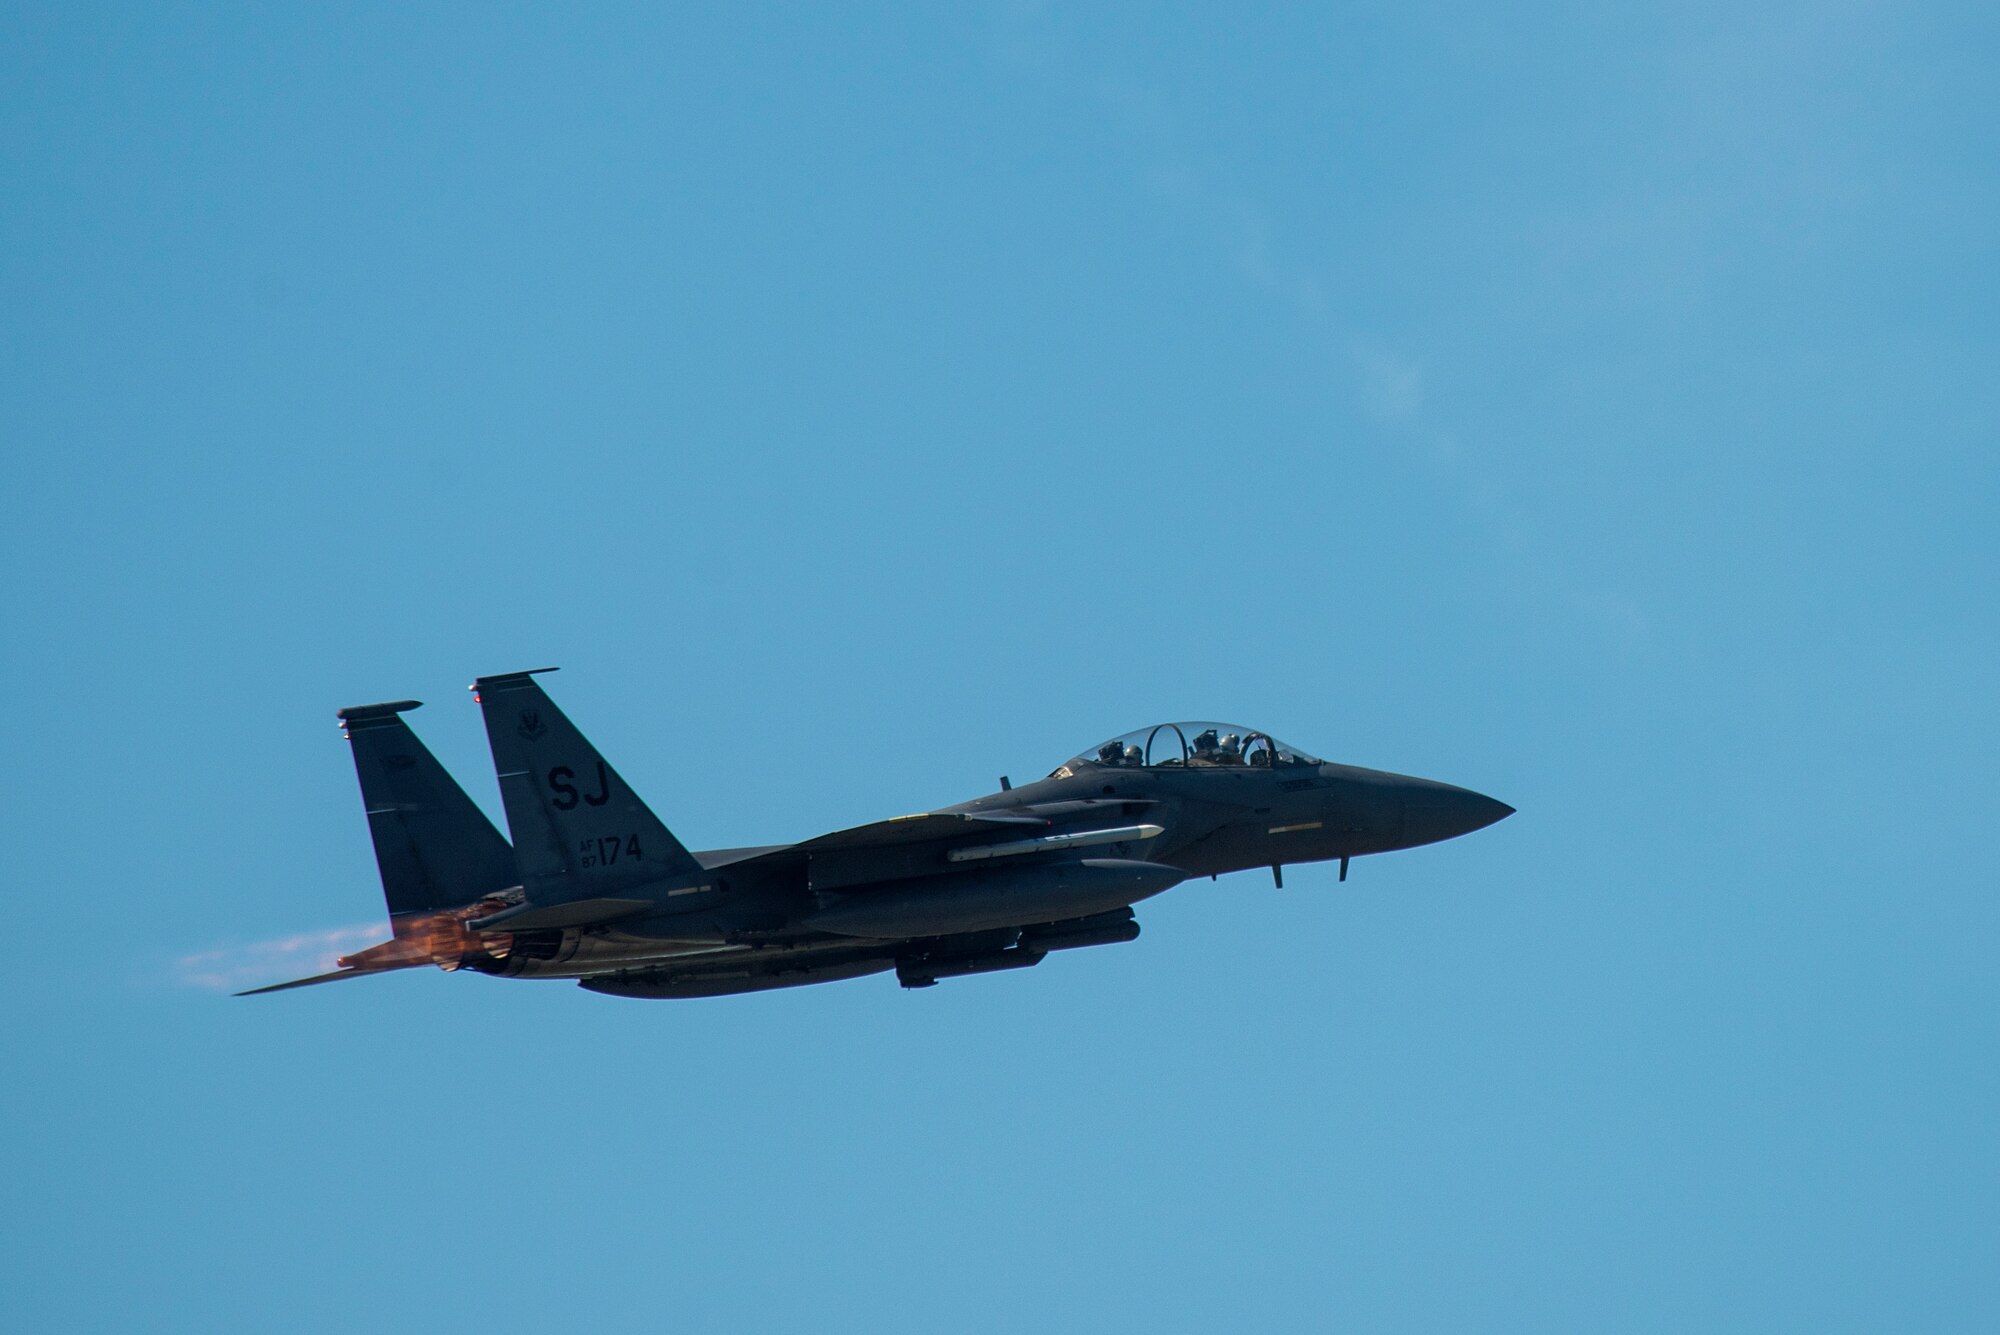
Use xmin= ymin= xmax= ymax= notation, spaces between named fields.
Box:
xmin=800 ymin=857 xmax=1188 ymax=937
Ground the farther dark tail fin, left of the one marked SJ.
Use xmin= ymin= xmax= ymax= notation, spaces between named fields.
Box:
xmin=338 ymin=699 xmax=520 ymax=919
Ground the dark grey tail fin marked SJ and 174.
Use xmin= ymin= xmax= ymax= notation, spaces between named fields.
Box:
xmin=472 ymin=668 xmax=702 ymax=903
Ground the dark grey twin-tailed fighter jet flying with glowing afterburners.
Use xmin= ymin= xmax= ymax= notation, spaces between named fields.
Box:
xmin=238 ymin=668 xmax=1514 ymax=997
